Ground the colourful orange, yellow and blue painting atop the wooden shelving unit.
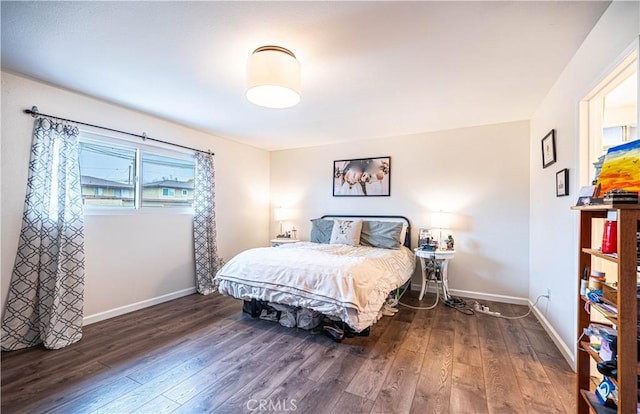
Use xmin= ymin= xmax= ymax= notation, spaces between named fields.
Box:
xmin=594 ymin=140 xmax=640 ymax=197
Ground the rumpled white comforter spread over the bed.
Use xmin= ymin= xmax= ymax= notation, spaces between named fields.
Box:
xmin=215 ymin=242 xmax=415 ymax=331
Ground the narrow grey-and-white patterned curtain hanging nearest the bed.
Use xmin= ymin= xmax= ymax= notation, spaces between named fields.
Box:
xmin=193 ymin=152 xmax=218 ymax=295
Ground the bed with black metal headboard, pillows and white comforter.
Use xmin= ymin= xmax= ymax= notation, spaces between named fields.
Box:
xmin=215 ymin=215 xmax=415 ymax=332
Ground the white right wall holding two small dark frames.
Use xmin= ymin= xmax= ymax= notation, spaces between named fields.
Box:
xmin=529 ymin=1 xmax=640 ymax=368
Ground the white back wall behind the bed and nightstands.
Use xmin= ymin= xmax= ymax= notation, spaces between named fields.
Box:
xmin=271 ymin=122 xmax=529 ymax=301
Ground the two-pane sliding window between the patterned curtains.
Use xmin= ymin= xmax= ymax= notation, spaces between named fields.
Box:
xmin=79 ymin=133 xmax=195 ymax=211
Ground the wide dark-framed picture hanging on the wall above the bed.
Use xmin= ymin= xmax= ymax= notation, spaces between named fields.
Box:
xmin=333 ymin=157 xmax=391 ymax=197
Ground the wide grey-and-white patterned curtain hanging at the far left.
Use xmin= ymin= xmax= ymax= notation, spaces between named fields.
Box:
xmin=2 ymin=118 xmax=84 ymax=351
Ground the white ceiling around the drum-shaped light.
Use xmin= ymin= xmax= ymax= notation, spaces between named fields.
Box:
xmin=1 ymin=1 xmax=609 ymax=150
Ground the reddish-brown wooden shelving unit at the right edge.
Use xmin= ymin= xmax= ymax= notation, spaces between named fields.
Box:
xmin=572 ymin=205 xmax=640 ymax=414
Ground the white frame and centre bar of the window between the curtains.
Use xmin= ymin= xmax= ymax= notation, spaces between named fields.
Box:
xmin=79 ymin=129 xmax=194 ymax=216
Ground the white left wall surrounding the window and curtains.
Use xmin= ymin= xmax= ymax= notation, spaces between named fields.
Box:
xmin=0 ymin=72 xmax=269 ymax=319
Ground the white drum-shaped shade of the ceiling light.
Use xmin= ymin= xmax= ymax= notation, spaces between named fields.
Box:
xmin=247 ymin=46 xmax=300 ymax=108
